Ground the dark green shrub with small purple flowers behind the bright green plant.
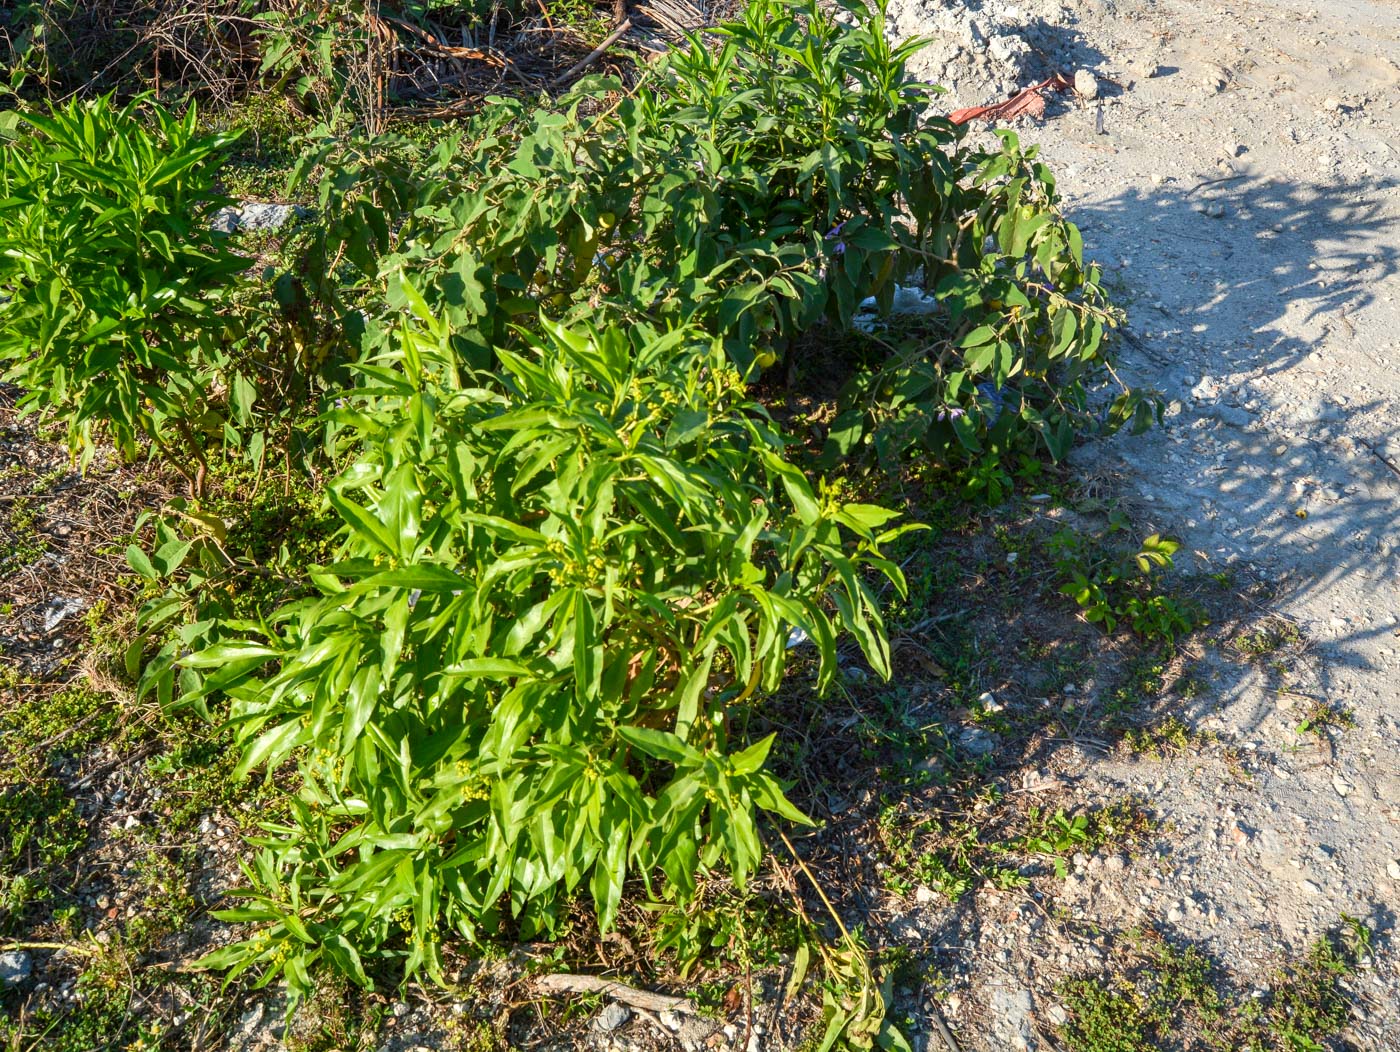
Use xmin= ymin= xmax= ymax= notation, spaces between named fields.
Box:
xmin=289 ymin=0 xmax=1151 ymax=473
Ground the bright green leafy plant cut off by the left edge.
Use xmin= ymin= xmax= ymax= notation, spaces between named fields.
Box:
xmin=0 ymin=98 xmax=249 ymax=482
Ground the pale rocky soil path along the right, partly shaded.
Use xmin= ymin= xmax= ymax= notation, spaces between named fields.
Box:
xmin=890 ymin=0 xmax=1400 ymax=1052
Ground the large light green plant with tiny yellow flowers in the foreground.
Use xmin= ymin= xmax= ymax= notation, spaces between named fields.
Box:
xmin=178 ymin=315 xmax=909 ymax=993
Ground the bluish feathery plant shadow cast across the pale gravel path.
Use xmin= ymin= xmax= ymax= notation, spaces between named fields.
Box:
xmin=1072 ymin=174 xmax=1400 ymax=734
